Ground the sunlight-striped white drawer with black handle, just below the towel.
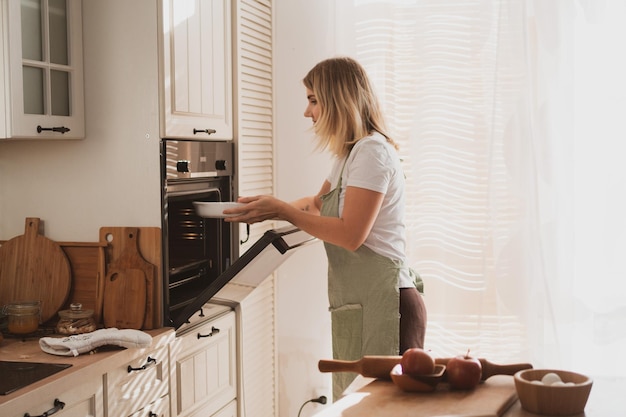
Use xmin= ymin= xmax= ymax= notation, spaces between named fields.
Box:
xmin=105 ymin=346 xmax=169 ymax=417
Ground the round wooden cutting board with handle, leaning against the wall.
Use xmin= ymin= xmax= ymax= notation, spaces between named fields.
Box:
xmin=0 ymin=217 xmax=72 ymax=323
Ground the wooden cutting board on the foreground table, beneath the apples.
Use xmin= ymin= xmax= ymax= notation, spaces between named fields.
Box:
xmin=316 ymin=375 xmax=517 ymax=417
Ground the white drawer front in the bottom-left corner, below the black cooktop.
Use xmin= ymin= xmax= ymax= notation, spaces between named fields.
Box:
xmin=5 ymin=377 xmax=104 ymax=417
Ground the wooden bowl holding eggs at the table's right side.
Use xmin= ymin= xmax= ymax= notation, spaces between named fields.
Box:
xmin=514 ymin=369 xmax=593 ymax=416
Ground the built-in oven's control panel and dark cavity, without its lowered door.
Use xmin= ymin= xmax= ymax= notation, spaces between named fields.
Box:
xmin=161 ymin=139 xmax=238 ymax=325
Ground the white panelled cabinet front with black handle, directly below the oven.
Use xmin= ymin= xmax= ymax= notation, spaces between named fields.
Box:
xmin=170 ymin=310 xmax=237 ymax=417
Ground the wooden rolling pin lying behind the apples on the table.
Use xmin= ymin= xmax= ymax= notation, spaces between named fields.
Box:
xmin=317 ymin=355 xmax=533 ymax=381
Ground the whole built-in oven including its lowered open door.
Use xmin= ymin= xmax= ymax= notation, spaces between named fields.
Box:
xmin=161 ymin=140 xmax=315 ymax=334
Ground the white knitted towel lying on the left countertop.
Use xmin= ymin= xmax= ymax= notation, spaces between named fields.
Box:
xmin=39 ymin=327 xmax=152 ymax=356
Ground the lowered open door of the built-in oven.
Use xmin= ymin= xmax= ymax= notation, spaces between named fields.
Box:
xmin=172 ymin=225 xmax=317 ymax=329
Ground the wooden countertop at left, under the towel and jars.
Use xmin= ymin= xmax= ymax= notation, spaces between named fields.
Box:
xmin=0 ymin=328 xmax=175 ymax=415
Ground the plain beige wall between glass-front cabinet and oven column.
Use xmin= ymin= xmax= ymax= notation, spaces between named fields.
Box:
xmin=0 ymin=0 xmax=161 ymax=241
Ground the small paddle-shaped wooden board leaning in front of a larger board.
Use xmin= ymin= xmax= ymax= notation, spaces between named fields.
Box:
xmin=101 ymin=227 xmax=156 ymax=329
